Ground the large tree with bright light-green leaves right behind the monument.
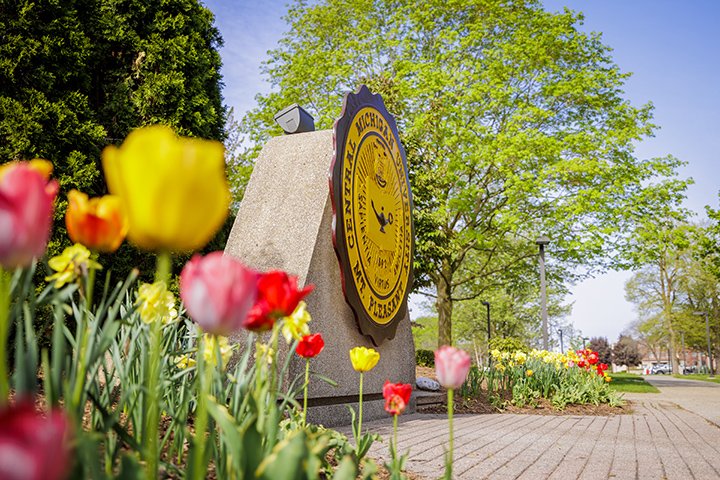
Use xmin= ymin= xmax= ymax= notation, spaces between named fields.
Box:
xmin=243 ymin=0 xmax=685 ymax=344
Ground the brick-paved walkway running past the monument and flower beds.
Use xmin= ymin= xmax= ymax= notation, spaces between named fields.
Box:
xmin=346 ymin=378 xmax=720 ymax=480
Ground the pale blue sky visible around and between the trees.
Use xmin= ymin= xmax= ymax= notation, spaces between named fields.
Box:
xmin=205 ymin=0 xmax=720 ymax=342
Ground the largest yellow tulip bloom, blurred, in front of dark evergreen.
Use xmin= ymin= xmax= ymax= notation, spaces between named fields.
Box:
xmin=102 ymin=125 xmax=230 ymax=252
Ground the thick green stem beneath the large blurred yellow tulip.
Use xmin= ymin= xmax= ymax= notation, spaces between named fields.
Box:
xmin=143 ymin=251 xmax=171 ymax=478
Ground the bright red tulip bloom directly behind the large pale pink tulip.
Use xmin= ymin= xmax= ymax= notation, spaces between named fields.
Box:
xmin=243 ymin=270 xmax=314 ymax=331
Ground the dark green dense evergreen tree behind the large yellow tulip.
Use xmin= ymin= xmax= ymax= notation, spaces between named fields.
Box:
xmin=0 ymin=0 xmax=224 ymax=274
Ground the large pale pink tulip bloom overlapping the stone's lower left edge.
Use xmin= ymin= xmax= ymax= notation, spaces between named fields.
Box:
xmin=180 ymin=252 xmax=257 ymax=336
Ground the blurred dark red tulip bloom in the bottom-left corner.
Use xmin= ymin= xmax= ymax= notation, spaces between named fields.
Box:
xmin=0 ymin=402 xmax=72 ymax=480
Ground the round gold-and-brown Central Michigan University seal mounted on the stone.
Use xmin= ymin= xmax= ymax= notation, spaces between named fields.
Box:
xmin=330 ymin=86 xmax=414 ymax=345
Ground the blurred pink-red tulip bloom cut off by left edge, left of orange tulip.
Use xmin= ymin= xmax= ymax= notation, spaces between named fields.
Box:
xmin=0 ymin=160 xmax=58 ymax=268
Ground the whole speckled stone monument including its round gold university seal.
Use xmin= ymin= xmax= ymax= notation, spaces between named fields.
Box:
xmin=225 ymin=87 xmax=415 ymax=426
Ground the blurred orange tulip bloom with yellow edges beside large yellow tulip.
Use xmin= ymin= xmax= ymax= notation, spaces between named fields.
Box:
xmin=65 ymin=190 xmax=128 ymax=252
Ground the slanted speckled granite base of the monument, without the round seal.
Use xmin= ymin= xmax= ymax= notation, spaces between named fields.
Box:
xmin=225 ymin=130 xmax=415 ymax=426
